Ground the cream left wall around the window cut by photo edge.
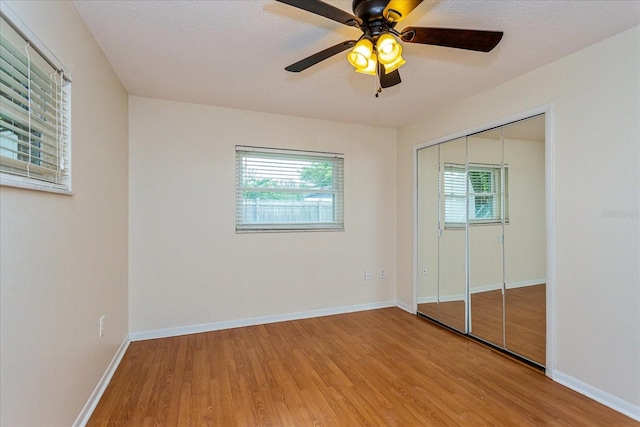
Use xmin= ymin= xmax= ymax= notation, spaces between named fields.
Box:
xmin=0 ymin=1 xmax=128 ymax=426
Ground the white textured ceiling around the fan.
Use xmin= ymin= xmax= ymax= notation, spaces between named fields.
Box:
xmin=73 ymin=0 xmax=640 ymax=127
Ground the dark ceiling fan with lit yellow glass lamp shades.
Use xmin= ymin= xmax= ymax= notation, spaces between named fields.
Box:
xmin=277 ymin=0 xmax=502 ymax=92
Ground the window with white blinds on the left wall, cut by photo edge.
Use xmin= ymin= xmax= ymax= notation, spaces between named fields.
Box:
xmin=0 ymin=8 xmax=71 ymax=192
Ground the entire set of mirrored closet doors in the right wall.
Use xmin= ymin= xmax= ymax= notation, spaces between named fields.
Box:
xmin=416 ymin=115 xmax=546 ymax=367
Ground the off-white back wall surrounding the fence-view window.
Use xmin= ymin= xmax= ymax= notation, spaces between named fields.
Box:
xmin=129 ymin=97 xmax=396 ymax=333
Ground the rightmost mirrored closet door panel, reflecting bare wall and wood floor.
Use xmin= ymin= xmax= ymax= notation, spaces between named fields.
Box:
xmin=503 ymin=116 xmax=547 ymax=366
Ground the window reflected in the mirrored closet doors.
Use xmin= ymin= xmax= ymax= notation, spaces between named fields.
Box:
xmin=444 ymin=163 xmax=509 ymax=228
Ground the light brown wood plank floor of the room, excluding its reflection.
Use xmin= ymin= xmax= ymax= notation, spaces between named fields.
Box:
xmin=88 ymin=308 xmax=637 ymax=427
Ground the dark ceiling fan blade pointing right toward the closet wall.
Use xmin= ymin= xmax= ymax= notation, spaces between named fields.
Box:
xmin=402 ymin=27 xmax=503 ymax=52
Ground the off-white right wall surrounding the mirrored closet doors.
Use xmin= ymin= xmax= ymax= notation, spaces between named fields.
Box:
xmin=397 ymin=27 xmax=640 ymax=416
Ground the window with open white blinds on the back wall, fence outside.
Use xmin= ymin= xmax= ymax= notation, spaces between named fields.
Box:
xmin=236 ymin=146 xmax=344 ymax=232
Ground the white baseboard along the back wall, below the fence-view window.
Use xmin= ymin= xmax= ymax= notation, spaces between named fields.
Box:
xmin=129 ymin=301 xmax=397 ymax=341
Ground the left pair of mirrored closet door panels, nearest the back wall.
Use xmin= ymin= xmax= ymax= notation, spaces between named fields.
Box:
xmin=417 ymin=138 xmax=468 ymax=332
